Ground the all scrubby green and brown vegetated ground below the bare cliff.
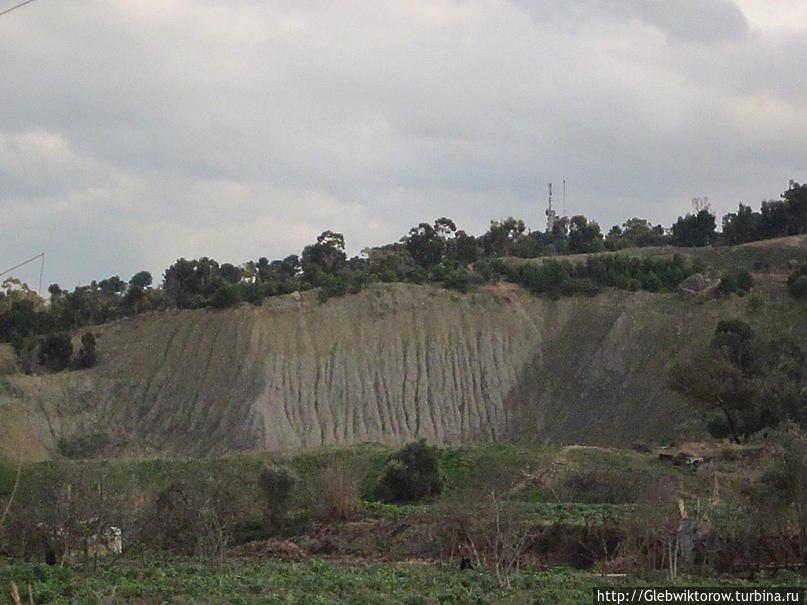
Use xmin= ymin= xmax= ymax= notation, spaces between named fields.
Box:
xmin=0 ymin=438 xmax=807 ymax=604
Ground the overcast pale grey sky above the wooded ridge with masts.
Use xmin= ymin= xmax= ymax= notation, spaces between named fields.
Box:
xmin=0 ymin=0 xmax=807 ymax=288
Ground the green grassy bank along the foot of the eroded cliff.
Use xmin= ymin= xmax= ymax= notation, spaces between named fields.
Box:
xmin=0 ymin=443 xmax=720 ymax=518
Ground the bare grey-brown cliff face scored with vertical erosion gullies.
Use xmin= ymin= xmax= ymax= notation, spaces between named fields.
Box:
xmin=0 ymin=284 xmax=744 ymax=458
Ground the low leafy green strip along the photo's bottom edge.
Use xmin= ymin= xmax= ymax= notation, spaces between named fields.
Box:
xmin=0 ymin=559 xmax=805 ymax=605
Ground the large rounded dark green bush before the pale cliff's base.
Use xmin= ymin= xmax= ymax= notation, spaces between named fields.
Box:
xmin=376 ymin=439 xmax=443 ymax=502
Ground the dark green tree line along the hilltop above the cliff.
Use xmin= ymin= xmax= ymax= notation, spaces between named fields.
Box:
xmin=0 ymin=181 xmax=807 ymax=350
